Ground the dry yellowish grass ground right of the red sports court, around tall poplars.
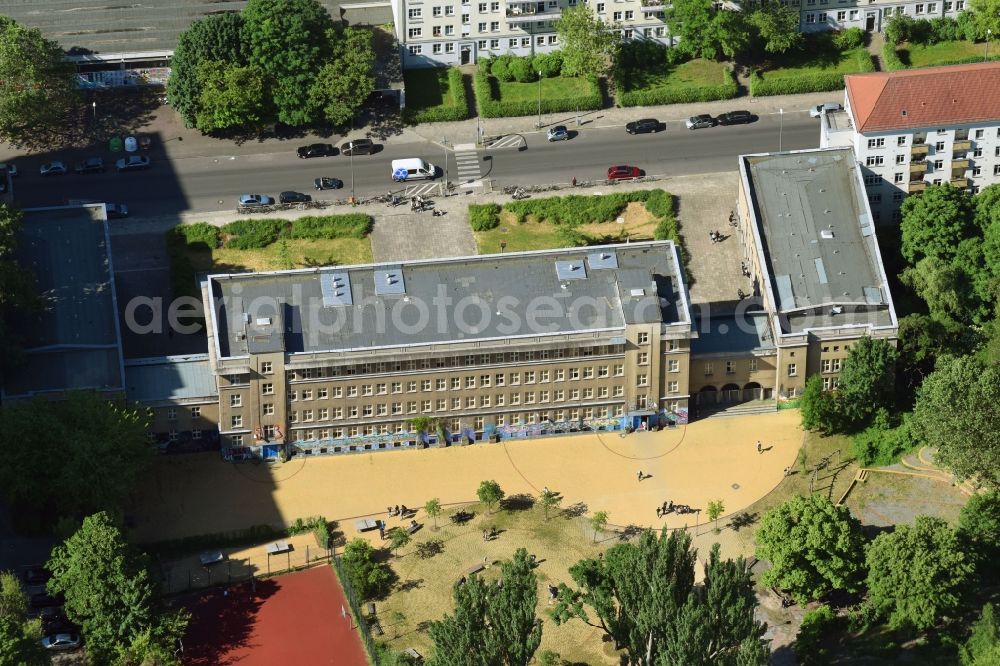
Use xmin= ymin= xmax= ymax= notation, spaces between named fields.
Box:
xmin=377 ymin=503 xmax=618 ymax=666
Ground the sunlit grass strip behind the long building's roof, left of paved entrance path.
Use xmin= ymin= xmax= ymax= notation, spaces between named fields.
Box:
xmin=187 ymin=237 xmax=372 ymax=272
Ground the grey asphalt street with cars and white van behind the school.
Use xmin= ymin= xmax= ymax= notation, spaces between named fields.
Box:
xmin=9 ymin=112 xmax=819 ymax=216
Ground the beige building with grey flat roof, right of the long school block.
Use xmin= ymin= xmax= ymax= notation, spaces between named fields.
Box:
xmin=732 ymin=148 xmax=897 ymax=397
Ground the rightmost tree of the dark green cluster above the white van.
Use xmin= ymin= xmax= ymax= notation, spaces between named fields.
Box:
xmin=309 ymin=28 xmax=375 ymax=125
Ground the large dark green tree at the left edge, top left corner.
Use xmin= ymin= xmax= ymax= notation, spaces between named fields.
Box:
xmin=0 ymin=16 xmax=80 ymax=150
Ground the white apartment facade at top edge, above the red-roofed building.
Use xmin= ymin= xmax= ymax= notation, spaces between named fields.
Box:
xmin=786 ymin=0 xmax=967 ymax=32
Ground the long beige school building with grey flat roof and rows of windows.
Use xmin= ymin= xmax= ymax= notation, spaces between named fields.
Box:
xmin=204 ymin=241 xmax=692 ymax=457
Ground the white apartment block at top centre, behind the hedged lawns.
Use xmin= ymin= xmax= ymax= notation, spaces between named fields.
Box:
xmin=392 ymin=0 xmax=669 ymax=68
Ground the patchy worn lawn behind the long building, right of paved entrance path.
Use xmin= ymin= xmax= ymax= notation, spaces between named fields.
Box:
xmin=474 ymin=202 xmax=656 ymax=254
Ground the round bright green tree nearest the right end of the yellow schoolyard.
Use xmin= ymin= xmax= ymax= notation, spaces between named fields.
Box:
xmin=756 ymin=495 xmax=864 ymax=605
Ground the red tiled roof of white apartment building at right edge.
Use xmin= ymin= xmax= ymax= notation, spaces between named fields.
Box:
xmin=844 ymin=62 xmax=1000 ymax=134
